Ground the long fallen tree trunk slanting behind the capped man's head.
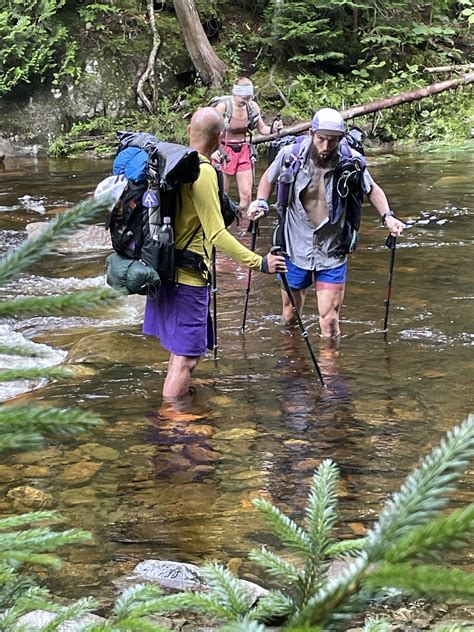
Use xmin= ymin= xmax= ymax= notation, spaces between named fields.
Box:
xmin=252 ymin=72 xmax=474 ymax=144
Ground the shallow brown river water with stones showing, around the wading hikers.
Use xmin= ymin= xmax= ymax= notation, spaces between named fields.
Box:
xmin=0 ymin=153 xmax=474 ymax=595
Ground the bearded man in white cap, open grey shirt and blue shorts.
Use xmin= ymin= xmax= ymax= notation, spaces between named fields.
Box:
xmin=248 ymin=108 xmax=404 ymax=338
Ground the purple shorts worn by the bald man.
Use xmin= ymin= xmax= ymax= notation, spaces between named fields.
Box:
xmin=143 ymin=280 xmax=213 ymax=357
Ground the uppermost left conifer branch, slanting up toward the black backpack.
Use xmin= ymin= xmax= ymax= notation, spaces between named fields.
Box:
xmin=0 ymin=196 xmax=113 ymax=285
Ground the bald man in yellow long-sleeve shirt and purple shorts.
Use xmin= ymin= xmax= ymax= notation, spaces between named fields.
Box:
xmin=143 ymin=107 xmax=286 ymax=400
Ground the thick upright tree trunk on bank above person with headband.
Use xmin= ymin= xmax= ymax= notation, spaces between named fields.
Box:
xmin=173 ymin=0 xmax=227 ymax=86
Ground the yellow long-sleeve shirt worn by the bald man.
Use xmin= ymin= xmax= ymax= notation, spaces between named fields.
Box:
xmin=175 ymin=156 xmax=262 ymax=286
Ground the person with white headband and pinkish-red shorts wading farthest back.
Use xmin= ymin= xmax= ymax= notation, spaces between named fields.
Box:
xmin=211 ymin=77 xmax=283 ymax=210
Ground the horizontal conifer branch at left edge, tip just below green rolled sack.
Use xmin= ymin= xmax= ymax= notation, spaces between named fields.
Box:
xmin=0 ymin=288 xmax=118 ymax=318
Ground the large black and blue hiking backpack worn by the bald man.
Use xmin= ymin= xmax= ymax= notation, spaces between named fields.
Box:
xmin=105 ymin=132 xmax=238 ymax=293
